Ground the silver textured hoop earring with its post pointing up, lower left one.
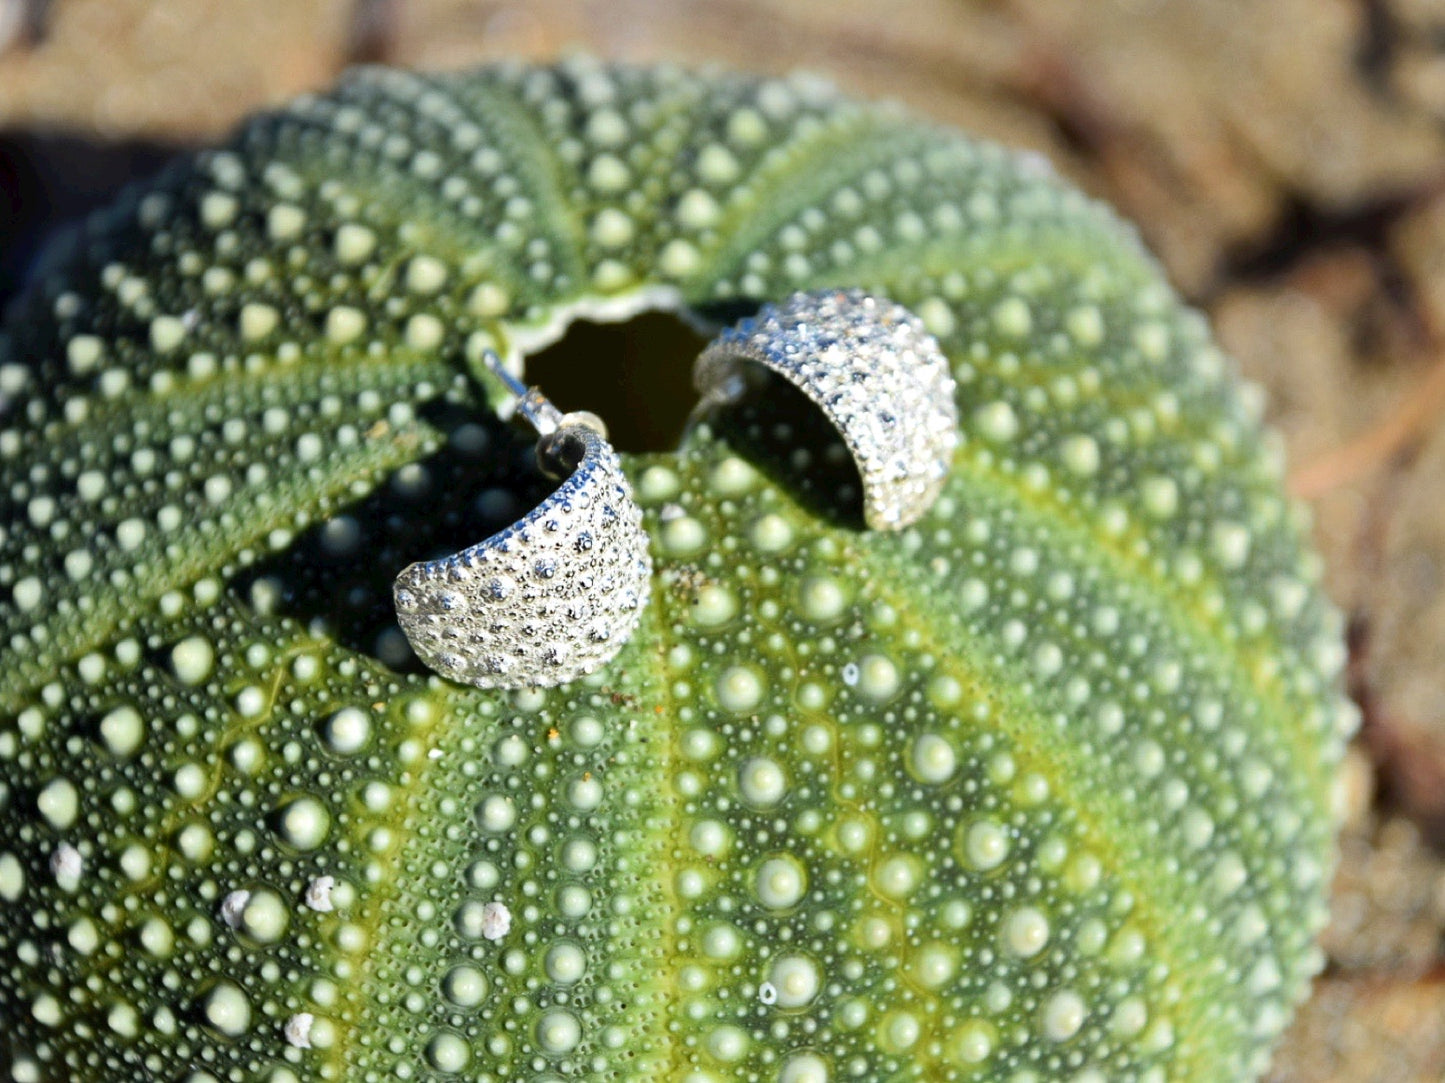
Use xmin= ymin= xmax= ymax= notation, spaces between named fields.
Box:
xmin=393 ymin=351 xmax=652 ymax=688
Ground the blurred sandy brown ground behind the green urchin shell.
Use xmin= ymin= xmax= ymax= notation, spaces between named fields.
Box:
xmin=0 ymin=0 xmax=1445 ymax=1083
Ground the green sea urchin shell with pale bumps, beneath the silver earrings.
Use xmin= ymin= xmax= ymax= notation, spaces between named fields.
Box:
xmin=0 ymin=64 xmax=1351 ymax=1083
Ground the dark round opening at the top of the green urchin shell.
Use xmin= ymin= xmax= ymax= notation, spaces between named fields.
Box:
xmin=525 ymin=312 xmax=707 ymax=453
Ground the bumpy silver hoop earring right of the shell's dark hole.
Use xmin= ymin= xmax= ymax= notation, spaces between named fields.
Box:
xmin=692 ymin=289 xmax=958 ymax=531
